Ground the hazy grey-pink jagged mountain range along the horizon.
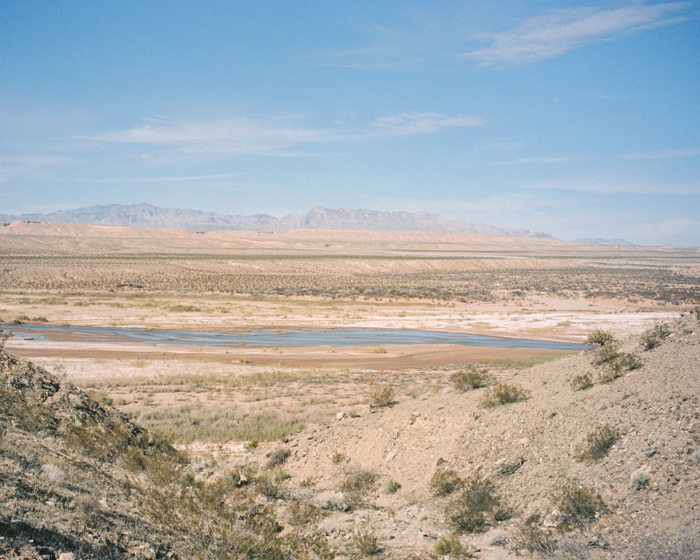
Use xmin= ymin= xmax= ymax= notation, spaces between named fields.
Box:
xmin=0 ymin=203 xmax=552 ymax=239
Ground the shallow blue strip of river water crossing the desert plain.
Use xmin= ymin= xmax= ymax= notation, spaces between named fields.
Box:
xmin=0 ymin=325 xmax=587 ymax=351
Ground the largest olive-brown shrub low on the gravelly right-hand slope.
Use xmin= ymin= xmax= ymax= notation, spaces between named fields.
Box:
xmin=445 ymin=472 xmax=501 ymax=533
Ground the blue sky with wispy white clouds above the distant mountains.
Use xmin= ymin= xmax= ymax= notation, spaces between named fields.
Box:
xmin=0 ymin=0 xmax=700 ymax=246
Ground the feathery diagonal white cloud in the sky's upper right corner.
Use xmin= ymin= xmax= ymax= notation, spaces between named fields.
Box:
xmin=461 ymin=2 xmax=691 ymax=65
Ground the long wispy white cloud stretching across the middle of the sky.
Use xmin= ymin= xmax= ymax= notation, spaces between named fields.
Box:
xmin=88 ymin=111 xmax=485 ymax=155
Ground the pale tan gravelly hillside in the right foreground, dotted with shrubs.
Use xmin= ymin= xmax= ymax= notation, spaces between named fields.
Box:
xmin=258 ymin=314 xmax=700 ymax=559
